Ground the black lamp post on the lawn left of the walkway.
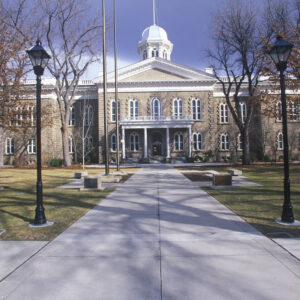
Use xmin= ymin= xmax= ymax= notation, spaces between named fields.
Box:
xmin=26 ymin=40 xmax=50 ymax=225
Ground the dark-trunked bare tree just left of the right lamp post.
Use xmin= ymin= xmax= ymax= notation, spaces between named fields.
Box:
xmin=208 ymin=0 xmax=264 ymax=164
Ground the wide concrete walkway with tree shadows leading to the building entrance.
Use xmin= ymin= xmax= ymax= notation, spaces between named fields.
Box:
xmin=0 ymin=166 xmax=300 ymax=300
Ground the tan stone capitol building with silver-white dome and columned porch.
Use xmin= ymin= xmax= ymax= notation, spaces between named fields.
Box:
xmin=2 ymin=25 xmax=300 ymax=163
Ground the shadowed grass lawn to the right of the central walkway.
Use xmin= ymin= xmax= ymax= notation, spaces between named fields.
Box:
xmin=180 ymin=165 xmax=300 ymax=237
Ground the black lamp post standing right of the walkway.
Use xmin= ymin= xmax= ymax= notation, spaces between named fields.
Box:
xmin=268 ymin=35 xmax=295 ymax=223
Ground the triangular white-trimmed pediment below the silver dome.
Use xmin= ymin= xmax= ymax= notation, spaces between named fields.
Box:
xmin=98 ymin=57 xmax=216 ymax=82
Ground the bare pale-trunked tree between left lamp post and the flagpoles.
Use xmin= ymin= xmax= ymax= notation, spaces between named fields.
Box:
xmin=40 ymin=0 xmax=100 ymax=166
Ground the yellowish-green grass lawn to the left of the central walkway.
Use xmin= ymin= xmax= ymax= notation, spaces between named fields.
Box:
xmin=0 ymin=168 xmax=135 ymax=241
